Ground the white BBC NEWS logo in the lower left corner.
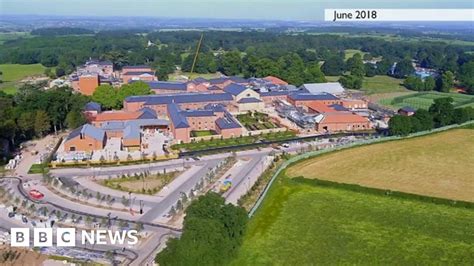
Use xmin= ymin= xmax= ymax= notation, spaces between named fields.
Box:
xmin=10 ymin=228 xmax=138 ymax=247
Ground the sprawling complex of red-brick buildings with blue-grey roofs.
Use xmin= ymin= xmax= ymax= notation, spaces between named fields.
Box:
xmin=62 ymin=61 xmax=373 ymax=161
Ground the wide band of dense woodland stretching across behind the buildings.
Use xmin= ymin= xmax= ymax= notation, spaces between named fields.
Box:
xmin=0 ymin=28 xmax=474 ymax=93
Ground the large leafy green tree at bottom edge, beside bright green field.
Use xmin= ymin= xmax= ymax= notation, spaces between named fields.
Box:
xmin=156 ymin=192 xmax=248 ymax=265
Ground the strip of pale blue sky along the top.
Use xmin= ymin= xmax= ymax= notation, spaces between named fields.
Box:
xmin=0 ymin=0 xmax=474 ymax=20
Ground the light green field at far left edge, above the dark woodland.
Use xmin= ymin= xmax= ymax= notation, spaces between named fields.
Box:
xmin=0 ymin=64 xmax=46 ymax=94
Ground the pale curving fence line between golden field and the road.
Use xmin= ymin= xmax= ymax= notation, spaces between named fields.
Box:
xmin=248 ymin=120 xmax=474 ymax=217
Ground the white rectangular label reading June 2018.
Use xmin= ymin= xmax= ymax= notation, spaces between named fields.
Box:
xmin=324 ymin=8 xmax=474 ymax=22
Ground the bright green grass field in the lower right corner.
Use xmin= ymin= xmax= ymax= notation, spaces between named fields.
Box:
xmin=231 ymin=176 xmax=474 ymax=265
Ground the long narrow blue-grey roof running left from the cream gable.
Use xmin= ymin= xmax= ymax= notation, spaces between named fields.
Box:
xmin=125 ymin=93 xmax=234 ymax=105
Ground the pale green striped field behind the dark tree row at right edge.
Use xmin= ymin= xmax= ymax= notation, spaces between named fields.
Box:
xmin=379 ymin=91 xmax=474 ymax=109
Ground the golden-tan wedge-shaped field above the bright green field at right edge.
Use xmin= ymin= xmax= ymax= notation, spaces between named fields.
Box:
xmin=287 ymin=129 xmax=474 ymax=202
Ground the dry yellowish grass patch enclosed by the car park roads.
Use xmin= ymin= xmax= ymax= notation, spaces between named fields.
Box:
xmin=99 ymin=171 xmax=181 ymax=195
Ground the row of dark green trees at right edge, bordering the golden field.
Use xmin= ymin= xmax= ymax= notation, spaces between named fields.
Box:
xmin=388 ymin=97 xmax=474 ymax=136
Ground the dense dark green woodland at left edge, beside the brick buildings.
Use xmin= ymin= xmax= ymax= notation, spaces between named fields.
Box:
xmin=0 ymin=84 xmax=90 ymax=162
